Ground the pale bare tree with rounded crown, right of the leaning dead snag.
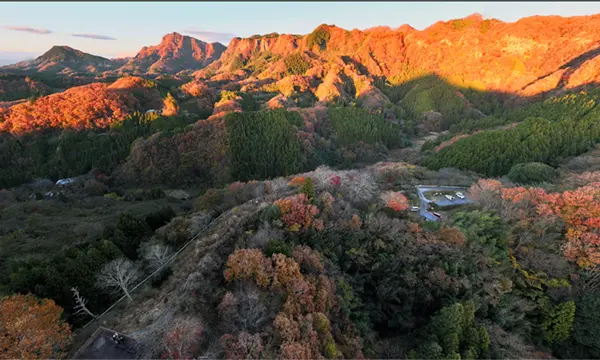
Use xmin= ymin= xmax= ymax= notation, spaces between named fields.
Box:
xmin=96 ymin=258 xmax=141 ymax=301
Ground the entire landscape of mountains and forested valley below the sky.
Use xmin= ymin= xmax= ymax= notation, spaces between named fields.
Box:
xmin=0 ymin=10 xmax=600 ymax=359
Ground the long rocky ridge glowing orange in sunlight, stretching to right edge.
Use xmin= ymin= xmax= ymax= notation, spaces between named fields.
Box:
xmin=196 ymin=14 xmax=600 ymax=101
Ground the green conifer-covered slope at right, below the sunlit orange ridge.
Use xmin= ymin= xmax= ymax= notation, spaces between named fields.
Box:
xmin=424 ymin=89 xmax=600 ymax=176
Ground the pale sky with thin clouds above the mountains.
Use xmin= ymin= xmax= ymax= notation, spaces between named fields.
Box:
xmin=0 ymin=1 xmax=600 ymax=65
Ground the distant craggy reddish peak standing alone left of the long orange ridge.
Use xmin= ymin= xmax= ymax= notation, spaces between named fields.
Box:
xmin=119 ymin=32 xmax=225 ymax=74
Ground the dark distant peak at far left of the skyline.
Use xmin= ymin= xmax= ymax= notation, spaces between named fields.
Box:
xmin=2 ymin=46 xmax=118 ymax=75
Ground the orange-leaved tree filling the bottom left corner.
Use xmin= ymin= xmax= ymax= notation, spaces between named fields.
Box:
xmin=0 ymin=295 xmax=71 ymax=359
